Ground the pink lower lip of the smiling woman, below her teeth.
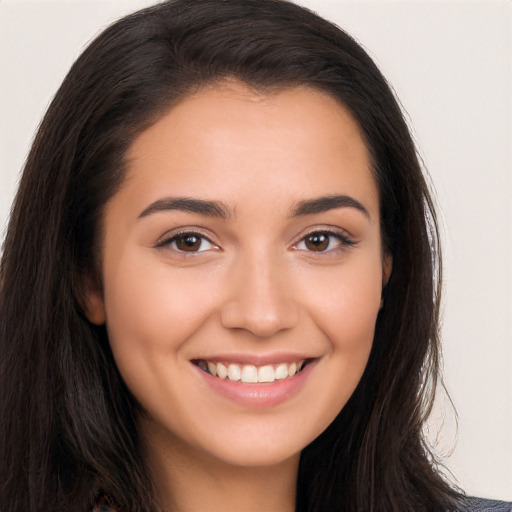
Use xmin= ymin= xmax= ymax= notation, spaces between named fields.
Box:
xmin=196 ymin=361 xmax=316 ymax=407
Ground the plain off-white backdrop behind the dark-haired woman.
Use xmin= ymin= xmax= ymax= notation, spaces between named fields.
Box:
xmin=0 ymin=0 xmax=512 ymax=500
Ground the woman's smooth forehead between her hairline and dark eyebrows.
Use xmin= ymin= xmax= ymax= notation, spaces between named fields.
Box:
xmin=122 ymin=81 xmax=378 ymax=220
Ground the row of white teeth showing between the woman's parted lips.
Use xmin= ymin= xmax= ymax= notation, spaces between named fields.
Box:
xmin=194 ymin=359 xmax=311 ymax=384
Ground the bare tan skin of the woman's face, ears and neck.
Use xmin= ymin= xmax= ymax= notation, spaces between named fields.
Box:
xmin=88 ymin=81 xmax=391 ymax=512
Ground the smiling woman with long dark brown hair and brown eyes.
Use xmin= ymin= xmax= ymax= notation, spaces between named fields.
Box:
xmin=0 ymin=0 xmax=510 ymax=512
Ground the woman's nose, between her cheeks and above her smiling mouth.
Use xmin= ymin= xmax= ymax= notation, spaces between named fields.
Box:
xmin=221 ymin=251 xmax=299 ymax=338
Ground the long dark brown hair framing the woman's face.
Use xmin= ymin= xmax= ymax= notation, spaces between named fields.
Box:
xmin=0 ymin=0 xmax=457 ymax=512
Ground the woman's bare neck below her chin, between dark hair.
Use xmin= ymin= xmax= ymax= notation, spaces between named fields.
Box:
xmin=141 ymin=420 xmax=300 ymax=512
